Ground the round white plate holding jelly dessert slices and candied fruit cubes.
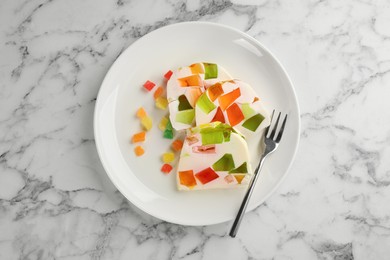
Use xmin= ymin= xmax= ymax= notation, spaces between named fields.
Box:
xmin=94 ymin=22 xmax=300 ymax=225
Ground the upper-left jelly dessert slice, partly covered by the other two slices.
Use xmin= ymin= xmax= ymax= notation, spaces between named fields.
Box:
xmin=167 ymin=62 xmax=231 ymax=130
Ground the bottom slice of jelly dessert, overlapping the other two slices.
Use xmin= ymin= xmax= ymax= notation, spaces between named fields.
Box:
xmin=176 ymin=122 xmax=252 ymax=190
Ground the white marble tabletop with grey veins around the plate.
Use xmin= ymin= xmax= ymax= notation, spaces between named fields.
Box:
xmin=0 ymin=0 xmax=390 ymax=260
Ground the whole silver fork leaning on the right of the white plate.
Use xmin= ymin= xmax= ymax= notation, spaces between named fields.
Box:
xmin=229 ymin=110 xmax=287 ymax=237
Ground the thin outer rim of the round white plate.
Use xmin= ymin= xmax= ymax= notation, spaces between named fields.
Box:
xmin=93 ymin=21 xmax=301 ymax=226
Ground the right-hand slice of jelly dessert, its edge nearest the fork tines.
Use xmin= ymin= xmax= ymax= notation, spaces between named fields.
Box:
xmin=195 ymin=80 xmax=270 ymax=139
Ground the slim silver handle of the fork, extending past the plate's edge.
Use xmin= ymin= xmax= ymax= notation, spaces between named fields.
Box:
xmin=229 ymin=155 xmax=265 ymax=237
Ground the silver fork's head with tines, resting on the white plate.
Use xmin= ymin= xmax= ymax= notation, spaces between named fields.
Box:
xmin=264 ymin=110 xmax=287 ymax=155
